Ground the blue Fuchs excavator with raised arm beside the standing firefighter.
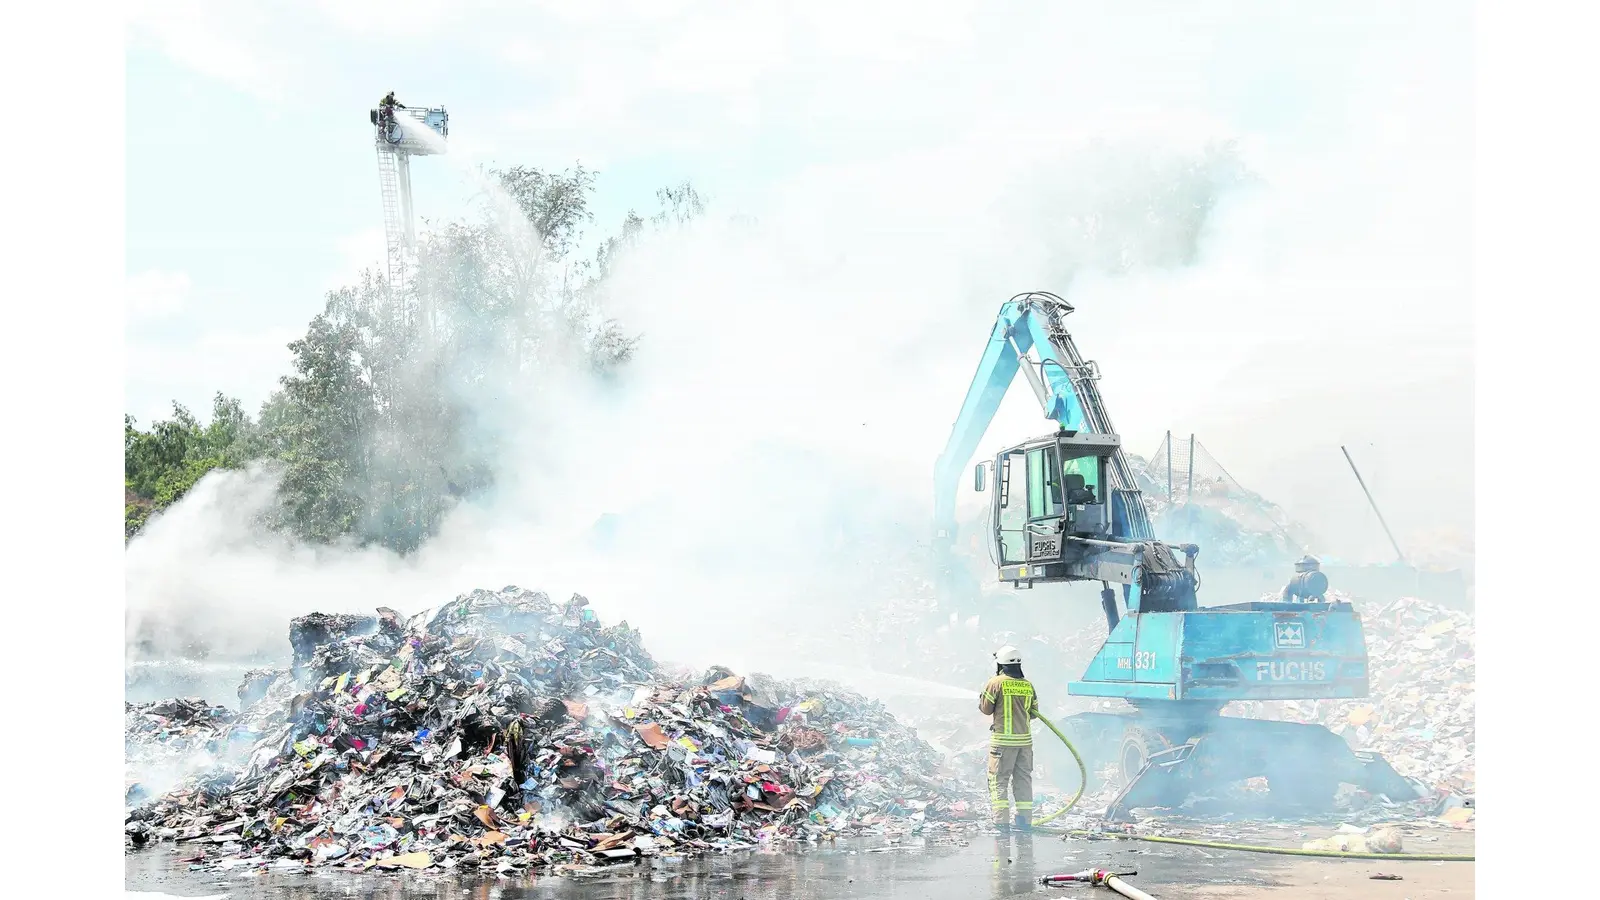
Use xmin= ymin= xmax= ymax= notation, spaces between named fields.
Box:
xmin=934 ymin=291 xmax=1421 ymax=818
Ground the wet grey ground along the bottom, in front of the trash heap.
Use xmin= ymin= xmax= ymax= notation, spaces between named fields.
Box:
xmin=125 ymin=834 xmax=1474 ymax=900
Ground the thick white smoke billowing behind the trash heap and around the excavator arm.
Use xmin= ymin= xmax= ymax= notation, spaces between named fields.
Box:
xmin=128 ymin=11 xmax=1472 ymax=682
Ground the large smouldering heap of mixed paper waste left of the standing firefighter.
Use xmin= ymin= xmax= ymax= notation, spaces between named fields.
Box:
xmin=126 ymin=588 xmax=982 ymax=874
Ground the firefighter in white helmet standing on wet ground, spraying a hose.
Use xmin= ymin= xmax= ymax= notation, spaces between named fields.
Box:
xmin=978 ymin=645 xmax=1038 ymax=831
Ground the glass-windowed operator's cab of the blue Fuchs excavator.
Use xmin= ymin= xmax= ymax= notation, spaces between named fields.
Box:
xmin=974 ymin=431 xmax=1122 ymax=570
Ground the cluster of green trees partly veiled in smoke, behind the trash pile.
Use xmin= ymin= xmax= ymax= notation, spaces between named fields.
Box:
xmin=125 ymin=167 xmax=704 ymax=552
